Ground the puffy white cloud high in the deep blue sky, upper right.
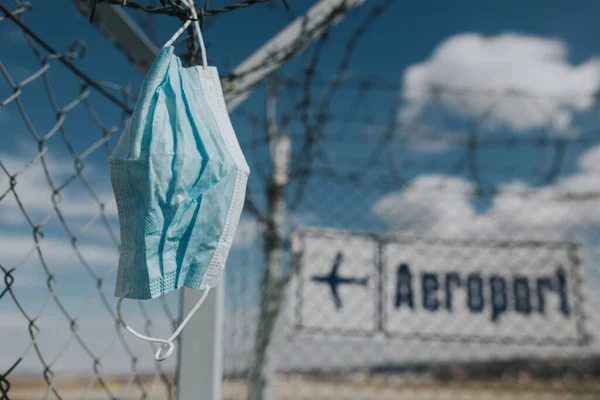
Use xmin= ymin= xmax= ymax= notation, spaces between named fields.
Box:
xmin=401 ymin=33 xmax=600 ymax=134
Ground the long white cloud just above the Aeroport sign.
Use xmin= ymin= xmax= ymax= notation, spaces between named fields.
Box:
xmin=373 ymin=146 xmax=600 ymax=239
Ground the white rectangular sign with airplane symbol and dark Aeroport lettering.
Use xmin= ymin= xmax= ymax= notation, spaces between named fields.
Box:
xmin=293 ymin=230 xmax=587 ymax=346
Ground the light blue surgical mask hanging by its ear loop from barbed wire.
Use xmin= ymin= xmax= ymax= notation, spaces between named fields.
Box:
xmin=109 ymin=0 xmax=250 ymax=361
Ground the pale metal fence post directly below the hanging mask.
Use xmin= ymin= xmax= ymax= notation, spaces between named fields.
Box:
xmin=177 ymin=277 xmax=225 ymax=400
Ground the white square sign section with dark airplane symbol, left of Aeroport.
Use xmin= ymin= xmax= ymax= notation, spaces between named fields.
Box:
xmin=294 ymin=233 xmax=378 ymax=335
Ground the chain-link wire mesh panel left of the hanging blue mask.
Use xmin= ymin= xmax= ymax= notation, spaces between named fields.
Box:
xmin=0 ymin=1 xmax=179 ymax=400
